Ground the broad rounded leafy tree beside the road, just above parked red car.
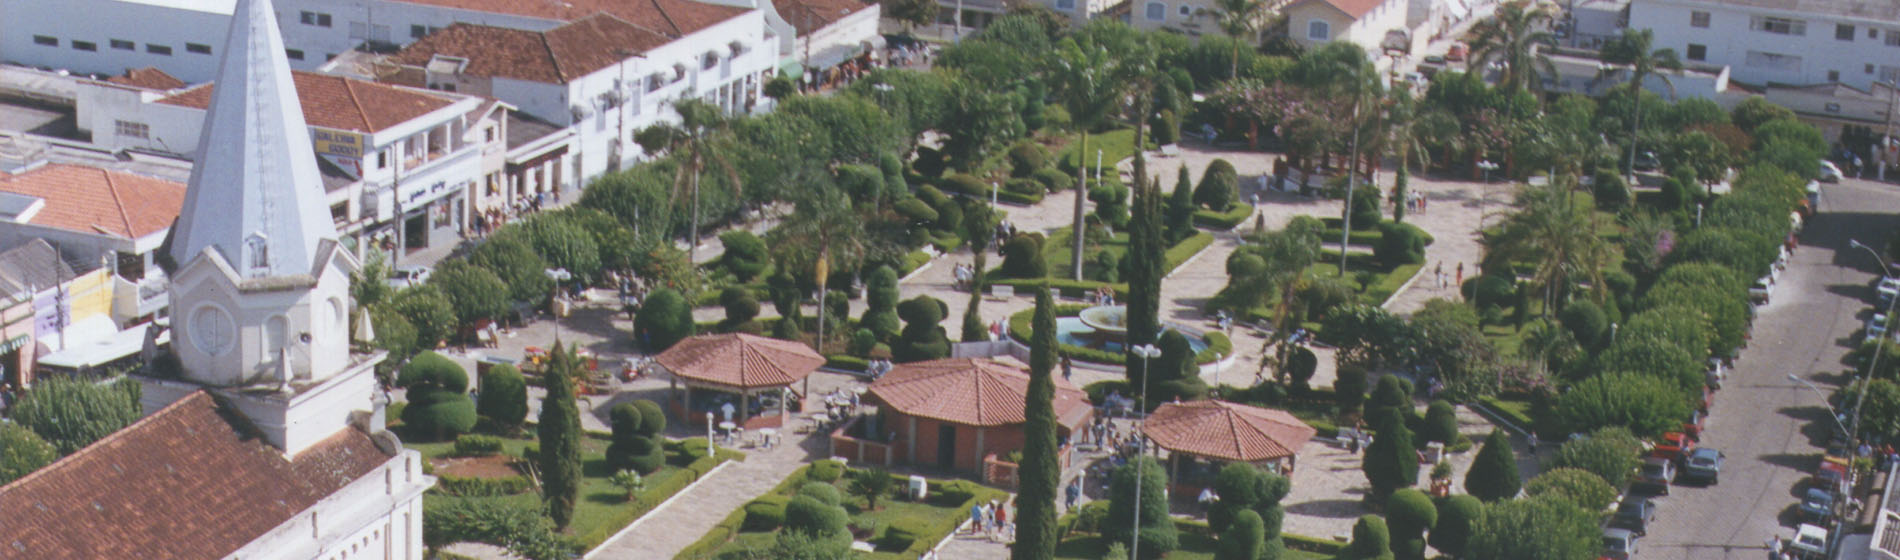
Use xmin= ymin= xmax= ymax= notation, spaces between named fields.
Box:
xmin=1552 ymin=372 xmax=1689 ymax=437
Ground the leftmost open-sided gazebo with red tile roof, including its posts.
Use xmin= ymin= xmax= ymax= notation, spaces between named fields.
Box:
xmin=654 ymin=332 xmax=825 ymax=427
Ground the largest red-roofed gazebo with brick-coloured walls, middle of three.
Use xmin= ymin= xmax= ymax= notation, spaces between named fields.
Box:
xmin=870 ymin=359 xmax=1094 ymax=471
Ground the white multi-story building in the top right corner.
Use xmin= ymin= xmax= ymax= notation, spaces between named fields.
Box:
xmin=1630 ymin=0 xmax=1900 ymax=89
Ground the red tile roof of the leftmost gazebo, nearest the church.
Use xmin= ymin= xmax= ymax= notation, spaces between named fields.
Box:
xmin=654 ymin=334 xmax=825 ymax=389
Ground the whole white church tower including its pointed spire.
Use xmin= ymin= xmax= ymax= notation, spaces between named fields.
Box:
xmin=144 ymin=0 xmax=382 ymax=456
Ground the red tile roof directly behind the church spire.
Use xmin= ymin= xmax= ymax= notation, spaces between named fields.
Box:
xmin=158 ymin=72 xmax=454 ymax=133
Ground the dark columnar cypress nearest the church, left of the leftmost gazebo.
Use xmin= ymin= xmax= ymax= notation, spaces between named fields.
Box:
xmin=536 ymin=342 xmax=581 ymax=530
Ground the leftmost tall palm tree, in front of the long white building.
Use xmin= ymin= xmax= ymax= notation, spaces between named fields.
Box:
xmin=635 ymin=99 xmax=739 ymax=262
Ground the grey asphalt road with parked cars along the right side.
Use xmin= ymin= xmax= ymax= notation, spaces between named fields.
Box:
xmin=1636 ymin=180 xmax=1900 ymax=560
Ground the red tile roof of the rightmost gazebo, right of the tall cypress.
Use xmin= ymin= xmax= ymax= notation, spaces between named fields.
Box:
xmin=1142 ymin=401 xmax=1317 ymax=461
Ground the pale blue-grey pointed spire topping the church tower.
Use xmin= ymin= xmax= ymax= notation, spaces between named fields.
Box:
xmin=171 ymin=0 xmax=336 ymax=277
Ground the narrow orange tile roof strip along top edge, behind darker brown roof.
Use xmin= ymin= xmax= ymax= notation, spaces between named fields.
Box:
xmin=401 ymin=0 xmax=751 ymax=38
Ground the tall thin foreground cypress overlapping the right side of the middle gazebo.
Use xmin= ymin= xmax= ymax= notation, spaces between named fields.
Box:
xmin=1009 ymin=289 xmax=1062 ymax=560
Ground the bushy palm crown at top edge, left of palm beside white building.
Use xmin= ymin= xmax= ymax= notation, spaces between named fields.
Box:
xmin=1471 ymin=0 xmax=1556 ymax=91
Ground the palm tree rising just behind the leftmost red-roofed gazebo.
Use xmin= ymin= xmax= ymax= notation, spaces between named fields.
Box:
xmin=768 ymin=184 xmax=865 ymax=353
